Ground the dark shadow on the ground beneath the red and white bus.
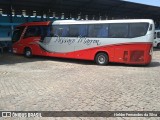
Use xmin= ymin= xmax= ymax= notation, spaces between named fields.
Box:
xmin=0 ymin=52 xmax=160 ymax=67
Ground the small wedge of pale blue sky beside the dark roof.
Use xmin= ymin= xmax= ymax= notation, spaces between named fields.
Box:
xmin=124 ymin=0 xmax=160 ymax=7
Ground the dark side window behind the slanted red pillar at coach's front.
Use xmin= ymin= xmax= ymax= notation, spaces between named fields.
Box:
xmin=23 ymin=26 xmax=41 ymax=38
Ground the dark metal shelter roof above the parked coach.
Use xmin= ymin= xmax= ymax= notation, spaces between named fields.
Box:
xmin=0 ymin=0 xmax=160 ymax=20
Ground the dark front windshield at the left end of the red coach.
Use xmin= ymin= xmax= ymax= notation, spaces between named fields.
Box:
xmin=12 ymin=27 xmax=24 ymax=42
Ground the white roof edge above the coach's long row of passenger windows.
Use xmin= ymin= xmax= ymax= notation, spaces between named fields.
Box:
xmin=52 ymin=19 xmax=153 ymax=25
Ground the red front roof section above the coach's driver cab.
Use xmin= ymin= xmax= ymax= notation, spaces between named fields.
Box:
xmin=18 ymin=21 xmax=51 ymax=27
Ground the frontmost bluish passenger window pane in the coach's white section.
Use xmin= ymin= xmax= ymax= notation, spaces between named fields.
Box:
xmin=54 ymin=25 xmax=69 ymax=37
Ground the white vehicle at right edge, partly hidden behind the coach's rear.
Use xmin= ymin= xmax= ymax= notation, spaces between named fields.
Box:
xmin=153 ymin=30 xmax=160 ymax=49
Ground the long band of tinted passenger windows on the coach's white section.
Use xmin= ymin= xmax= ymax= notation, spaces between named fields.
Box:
xmin=51 ymin=23 xmax=151 ymax=38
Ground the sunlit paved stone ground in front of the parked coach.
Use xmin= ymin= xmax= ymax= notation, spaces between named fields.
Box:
xmin=0 ymin=50 xmax=160 ymax=120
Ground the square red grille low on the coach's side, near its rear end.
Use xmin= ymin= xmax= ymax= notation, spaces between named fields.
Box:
xmin=130 ymin=50 xmax=144 ymax=62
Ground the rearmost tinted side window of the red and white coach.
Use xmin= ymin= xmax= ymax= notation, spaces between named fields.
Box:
xmin=129 ymin=23 xmax=149 ymax=38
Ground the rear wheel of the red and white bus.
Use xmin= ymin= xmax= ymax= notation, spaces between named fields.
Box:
xmin=95 ymin=53 xmax=109 ymax=65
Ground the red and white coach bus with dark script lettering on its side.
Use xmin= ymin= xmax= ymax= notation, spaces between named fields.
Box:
xmin=12 ymin=19 xmax=155 ymax=65
